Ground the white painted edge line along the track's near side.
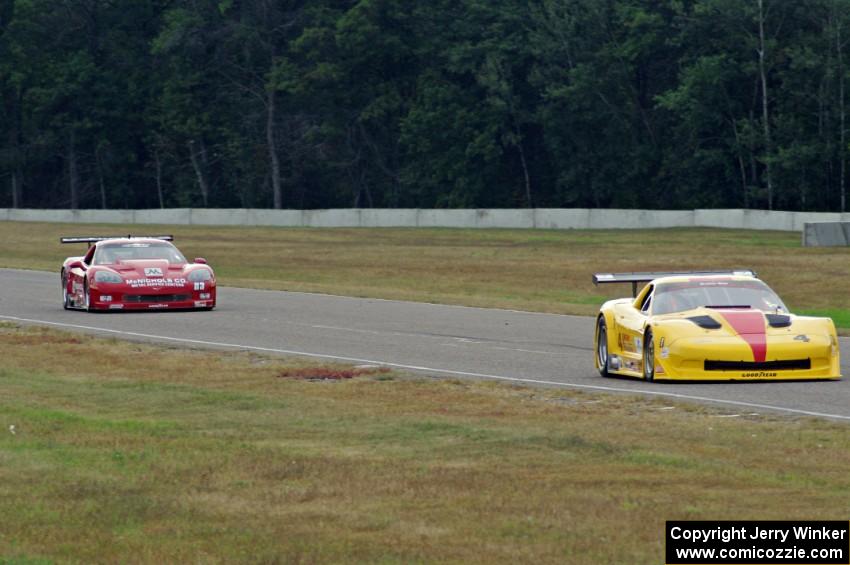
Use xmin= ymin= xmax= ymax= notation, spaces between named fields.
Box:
xmin=0 ymin=314 xmax=850 ymax=421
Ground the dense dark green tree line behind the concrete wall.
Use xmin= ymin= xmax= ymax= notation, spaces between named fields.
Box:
xmin=0 ymin=0 xmax=850 ymax=211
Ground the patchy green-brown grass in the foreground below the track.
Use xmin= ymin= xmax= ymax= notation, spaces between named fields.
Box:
xmin=0 ymin=324 xmax=850 ymax=565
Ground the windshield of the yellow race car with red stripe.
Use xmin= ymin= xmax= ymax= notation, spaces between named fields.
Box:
xmin=652 ymin=280 xmax=788 ymax=315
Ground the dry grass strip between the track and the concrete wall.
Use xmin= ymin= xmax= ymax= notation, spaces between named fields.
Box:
xmin=0 ymin=222 xmax=850 ymax=328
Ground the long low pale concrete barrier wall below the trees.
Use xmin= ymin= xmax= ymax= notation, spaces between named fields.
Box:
xmin=0 ymin=208 xmax=850 ymax=232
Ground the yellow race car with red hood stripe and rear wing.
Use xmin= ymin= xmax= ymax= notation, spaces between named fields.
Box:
xmin=593 ymin=271 xmax=841 ymax=381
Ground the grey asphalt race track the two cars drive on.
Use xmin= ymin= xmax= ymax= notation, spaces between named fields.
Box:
xmin=0 ymin=269 xmax=850 ymax=420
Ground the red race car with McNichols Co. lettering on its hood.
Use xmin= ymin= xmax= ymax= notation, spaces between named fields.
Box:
xmin=60 ymin=235 xmax=215 ymax=312
